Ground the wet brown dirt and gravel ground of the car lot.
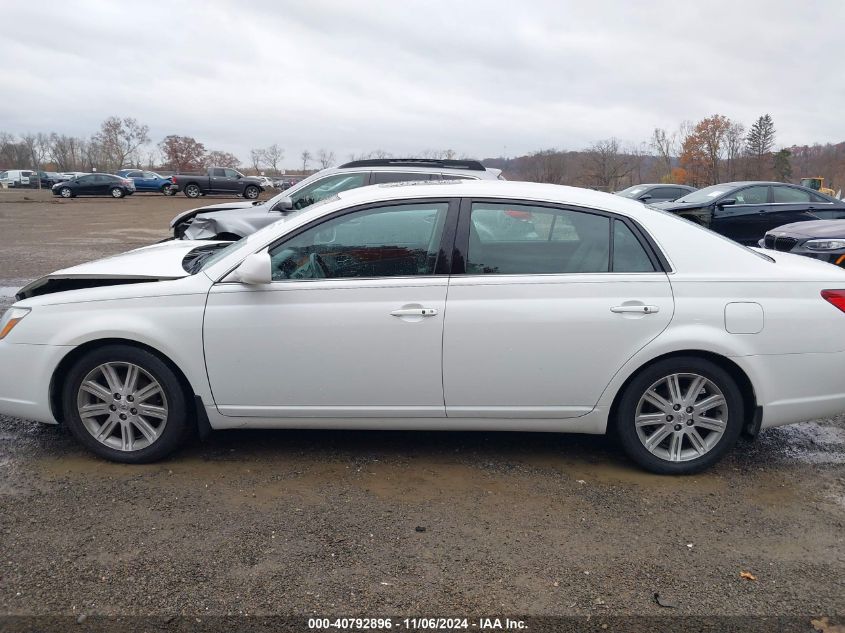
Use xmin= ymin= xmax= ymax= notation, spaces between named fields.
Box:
xmin=0 ymin=191 xmax=845 ymax=631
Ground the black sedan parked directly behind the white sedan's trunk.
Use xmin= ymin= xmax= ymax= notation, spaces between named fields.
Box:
xmin=650 ymin=181 xmax=845 ymax=246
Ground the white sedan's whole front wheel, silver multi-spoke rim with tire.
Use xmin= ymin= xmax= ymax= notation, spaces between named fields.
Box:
xmin=63 ymin=345 xmax=190 ymax=463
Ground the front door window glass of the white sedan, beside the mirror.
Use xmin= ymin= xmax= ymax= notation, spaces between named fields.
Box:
xmin=270 ymin=202 xmax=449 ymax=281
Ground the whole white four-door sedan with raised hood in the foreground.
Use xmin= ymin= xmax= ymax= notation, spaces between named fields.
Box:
xmin=0 ymin=181 xmax=845 ymax=473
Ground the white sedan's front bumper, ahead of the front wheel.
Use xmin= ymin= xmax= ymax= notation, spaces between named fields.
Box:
xmin=0 ymin=341 xmax=73 ymax=424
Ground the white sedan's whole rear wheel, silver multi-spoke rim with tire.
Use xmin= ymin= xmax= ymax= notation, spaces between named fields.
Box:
xmin=616 ymin=358 xmax=743 ymax=474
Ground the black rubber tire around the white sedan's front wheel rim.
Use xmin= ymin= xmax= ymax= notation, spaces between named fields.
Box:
xmin=62 ymin=344 xmax=195 ymax=464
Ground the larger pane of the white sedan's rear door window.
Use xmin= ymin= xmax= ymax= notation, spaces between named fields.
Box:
xmin=467 ymin=202 xmax=610 ymax=275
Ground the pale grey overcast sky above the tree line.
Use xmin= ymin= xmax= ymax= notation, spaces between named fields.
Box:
xmin=0 ymin=0 xmax=845 ymax=166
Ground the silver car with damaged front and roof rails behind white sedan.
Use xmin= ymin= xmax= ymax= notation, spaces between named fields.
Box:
xmin=170 ymin=158 xmax=503 ymax=241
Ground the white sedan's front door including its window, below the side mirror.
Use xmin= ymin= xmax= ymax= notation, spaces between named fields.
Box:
xmin=204 ymin=195 xmax=456 ymax=418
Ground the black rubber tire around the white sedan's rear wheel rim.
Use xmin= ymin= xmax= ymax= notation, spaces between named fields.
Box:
xmin=612 ymin=356 xmax=744 ymax=475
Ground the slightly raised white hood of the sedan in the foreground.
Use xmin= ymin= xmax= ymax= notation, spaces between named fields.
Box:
xmin=17 ymin=240 xmax=209 ymax=300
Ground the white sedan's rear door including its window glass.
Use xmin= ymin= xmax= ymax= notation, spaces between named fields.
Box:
xmin=443 ymin=201 xmax=674 ymax=419
